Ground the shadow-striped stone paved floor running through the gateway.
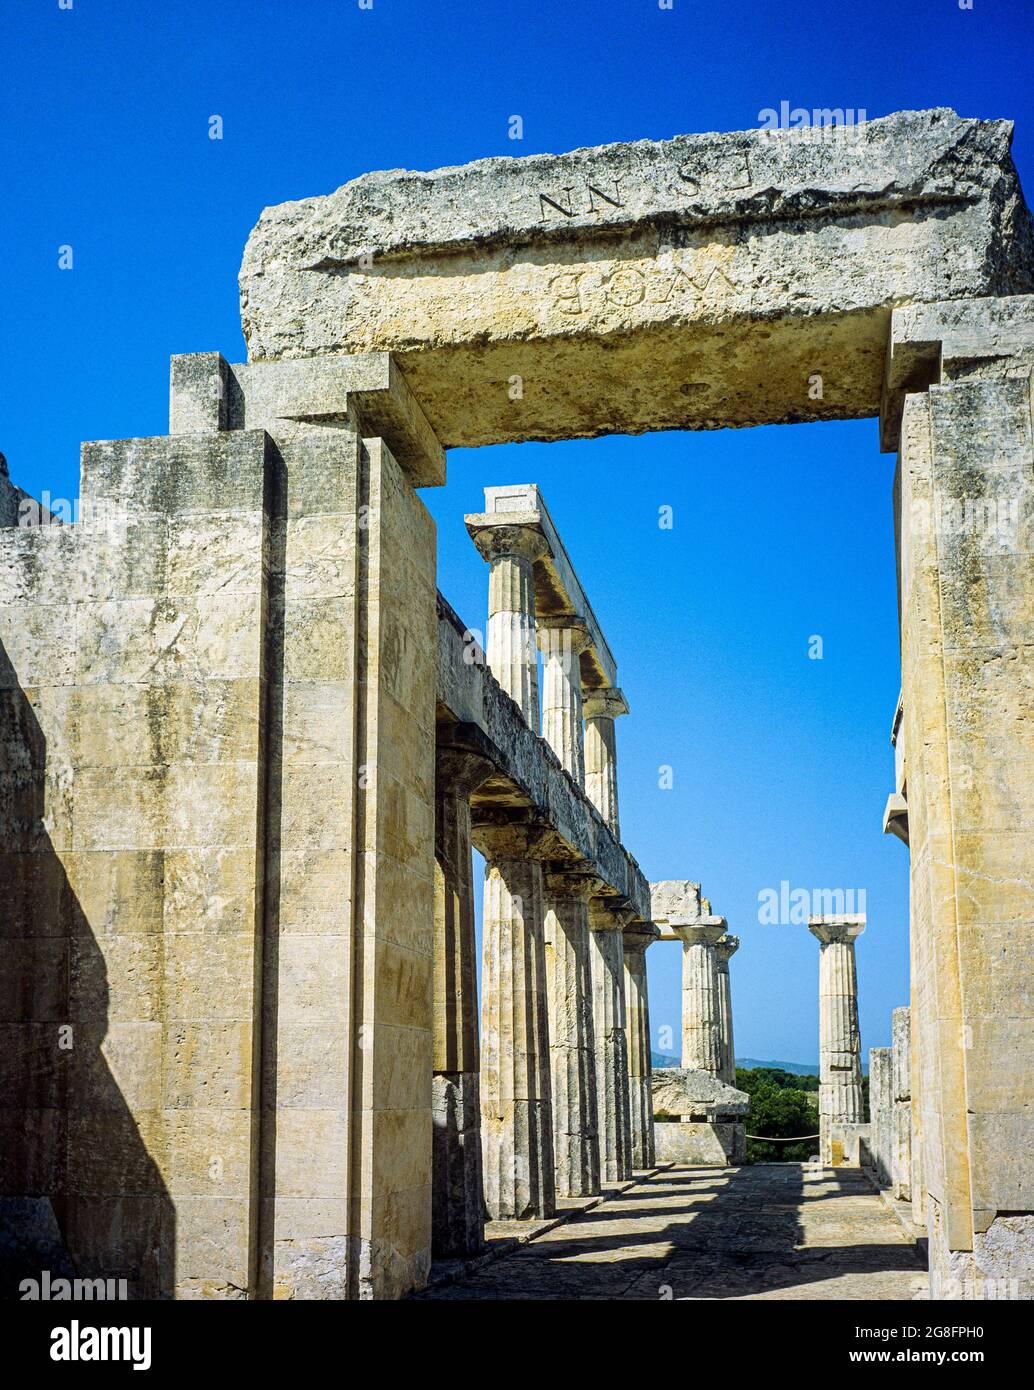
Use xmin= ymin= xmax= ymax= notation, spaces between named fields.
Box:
xmin=418 ymin=1163 xmax=927 ymax=1300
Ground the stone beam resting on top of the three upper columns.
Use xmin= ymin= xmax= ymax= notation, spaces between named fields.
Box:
xmin=464 ymin=482 xmax=617 ymax=691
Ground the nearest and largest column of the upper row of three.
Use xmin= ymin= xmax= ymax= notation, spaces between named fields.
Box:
xmin=475 ymin=525 xmax=546 ymax=734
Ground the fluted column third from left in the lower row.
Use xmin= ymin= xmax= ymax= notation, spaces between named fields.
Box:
xmin=545 ymin=869 xmax=600 ymax=1197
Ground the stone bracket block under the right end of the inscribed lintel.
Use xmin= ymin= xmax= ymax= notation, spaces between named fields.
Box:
xmin=880 ymin=295 xmax=1034 ymax=453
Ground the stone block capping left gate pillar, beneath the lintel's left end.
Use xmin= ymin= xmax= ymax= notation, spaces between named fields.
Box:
xmin=168 ymin=352 xmax=445 ymax=488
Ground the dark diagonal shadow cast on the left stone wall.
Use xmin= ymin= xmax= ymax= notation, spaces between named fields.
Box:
xmin=0 ymin=642 xmax=175 ymax=1300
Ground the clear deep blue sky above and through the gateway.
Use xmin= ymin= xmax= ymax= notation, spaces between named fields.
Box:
xmin=0 ymin=0 xmax=1034 ymax=1061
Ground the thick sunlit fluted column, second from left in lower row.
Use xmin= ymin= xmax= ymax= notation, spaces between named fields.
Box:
xmin=474 ymin=819 xmax=556 ymax=1220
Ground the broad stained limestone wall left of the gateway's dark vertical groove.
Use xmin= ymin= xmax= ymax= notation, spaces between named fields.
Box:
xmin=0 ymin=431 xmax=275 ymax=1298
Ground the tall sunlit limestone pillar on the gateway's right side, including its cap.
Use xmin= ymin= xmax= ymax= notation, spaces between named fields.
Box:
xmin=885 ymin=297 xmax=1034 ymax=1298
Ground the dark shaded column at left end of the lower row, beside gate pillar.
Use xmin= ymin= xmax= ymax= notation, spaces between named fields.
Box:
xmin=431 ymin=746 xmax=492 ymax=1259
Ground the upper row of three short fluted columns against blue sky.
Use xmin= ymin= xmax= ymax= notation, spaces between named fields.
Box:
xmin=478 ymin=524 xmax=628 ymax=822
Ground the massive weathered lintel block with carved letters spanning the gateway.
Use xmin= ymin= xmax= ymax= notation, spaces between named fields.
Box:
xmin=240 ymin=108 xmax=1031 ymax=448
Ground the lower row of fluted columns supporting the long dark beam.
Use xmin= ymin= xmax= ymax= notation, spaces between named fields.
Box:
xmin=434 ymin=746 xmax=659 ymax=1258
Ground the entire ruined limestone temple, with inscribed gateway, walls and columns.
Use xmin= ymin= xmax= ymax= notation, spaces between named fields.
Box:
xmin=0 ymin=110 xmax=1034 ymax=1298
